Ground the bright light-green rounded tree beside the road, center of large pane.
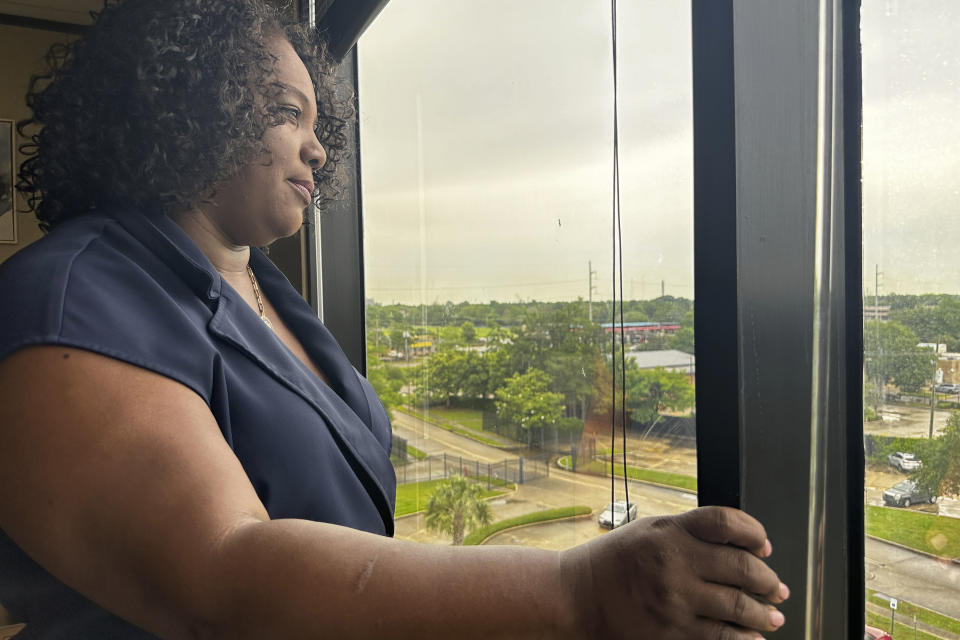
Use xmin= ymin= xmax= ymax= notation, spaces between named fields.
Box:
xmin=495 ymin=369 xmax=563 ymax=445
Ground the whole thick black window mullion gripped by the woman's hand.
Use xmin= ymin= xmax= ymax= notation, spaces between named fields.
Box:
xmin=693 ymin=0 xmax=863 ymax=638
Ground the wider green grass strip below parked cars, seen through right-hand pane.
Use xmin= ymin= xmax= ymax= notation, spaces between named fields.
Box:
xmin=864 ymin=505 xmax=960 ymax=558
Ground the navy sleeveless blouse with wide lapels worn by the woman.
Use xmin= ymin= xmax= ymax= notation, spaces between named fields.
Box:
xmin=0 ymin=212 xmax=396 ymax=640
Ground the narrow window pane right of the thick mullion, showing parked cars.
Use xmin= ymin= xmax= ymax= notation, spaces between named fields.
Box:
xmin=861 ymin=0 xmax=960 ymax=638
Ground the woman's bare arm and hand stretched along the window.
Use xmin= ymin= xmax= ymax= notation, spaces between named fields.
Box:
xmin=0 ymin=347 xmax=781 ymax=639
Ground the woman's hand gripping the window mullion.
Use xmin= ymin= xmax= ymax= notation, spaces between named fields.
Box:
xmin=562 ymin=507 xmax=789 ymax=640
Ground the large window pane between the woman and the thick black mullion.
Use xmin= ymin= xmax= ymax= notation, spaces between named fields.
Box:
xmin=359 ymin=0 xmax=696 ymax=548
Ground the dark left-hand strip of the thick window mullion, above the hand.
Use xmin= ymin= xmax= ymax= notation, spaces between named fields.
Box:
xmin=691 ymin=0 xmax=740 ymax=507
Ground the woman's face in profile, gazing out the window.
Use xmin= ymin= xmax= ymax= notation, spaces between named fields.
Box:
xmin=202 ymin=37 xmax=327 ymax=246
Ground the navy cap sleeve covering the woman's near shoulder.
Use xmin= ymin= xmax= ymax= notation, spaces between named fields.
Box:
xmin=0 ymin=214 xmax=219 ymax=398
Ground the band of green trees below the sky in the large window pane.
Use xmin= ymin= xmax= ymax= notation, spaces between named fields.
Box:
xmin=367 ymin=296 xmax=694 ymax=443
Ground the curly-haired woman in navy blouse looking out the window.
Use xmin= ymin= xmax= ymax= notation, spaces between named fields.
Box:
xmin=0 ymin=0 xmax=788 ymax=639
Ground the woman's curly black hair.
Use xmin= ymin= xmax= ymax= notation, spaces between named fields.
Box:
xmin=17 ymin=0 xmax=353 ymax=231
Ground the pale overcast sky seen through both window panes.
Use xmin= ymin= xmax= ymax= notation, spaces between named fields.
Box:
xmin=359 ymin=0 xmax=960 ymax=303
